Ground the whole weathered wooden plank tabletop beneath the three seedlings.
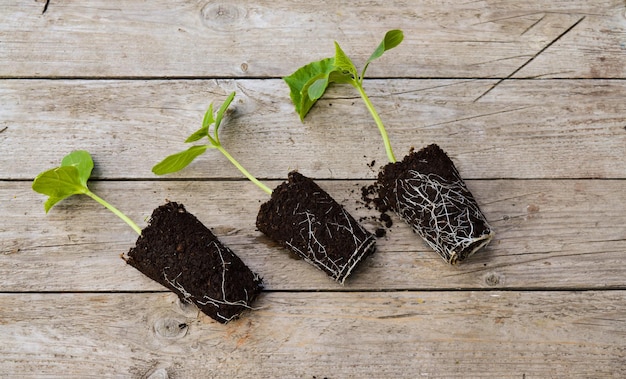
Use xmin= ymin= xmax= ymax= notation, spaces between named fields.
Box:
xmin=0 ymin=0 xmax=626 ymax=379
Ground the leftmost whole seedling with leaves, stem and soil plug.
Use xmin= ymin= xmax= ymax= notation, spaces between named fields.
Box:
xmin=33 ymin=150 xmax=263 ymax=323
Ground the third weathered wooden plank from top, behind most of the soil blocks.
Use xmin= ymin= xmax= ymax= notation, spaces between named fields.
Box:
xmin=0 ymin=180 xmax=626 ymax=291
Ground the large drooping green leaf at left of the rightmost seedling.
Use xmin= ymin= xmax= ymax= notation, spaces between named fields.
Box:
xmin=283 ymin=58 xmax=335 ymax=120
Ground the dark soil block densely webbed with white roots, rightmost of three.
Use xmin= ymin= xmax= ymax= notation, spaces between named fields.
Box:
xmin=375 ymin=144 xmax=494 ymax=264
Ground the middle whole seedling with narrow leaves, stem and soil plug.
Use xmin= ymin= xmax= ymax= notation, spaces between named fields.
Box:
xmin=152 ymin=92 xmax=376 ymax=284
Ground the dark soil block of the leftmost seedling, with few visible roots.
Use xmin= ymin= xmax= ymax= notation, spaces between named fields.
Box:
xmin=124 ymin=202 xmax=263 ymax=323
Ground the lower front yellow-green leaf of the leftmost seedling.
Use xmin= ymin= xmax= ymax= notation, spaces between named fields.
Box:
xmin=33 ymin=165 xmax=89 ymax=213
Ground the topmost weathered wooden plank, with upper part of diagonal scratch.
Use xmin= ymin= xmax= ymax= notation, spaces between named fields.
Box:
xmin=0 ymin=0 xmax=626 ymax=78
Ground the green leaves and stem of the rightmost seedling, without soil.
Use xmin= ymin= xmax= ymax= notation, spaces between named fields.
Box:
xmin=283 ymin=30 xmax=404 ymax=163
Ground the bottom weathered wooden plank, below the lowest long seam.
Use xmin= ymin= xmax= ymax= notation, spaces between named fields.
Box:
xmin=0 ymin=291 xmax=626 ymax=378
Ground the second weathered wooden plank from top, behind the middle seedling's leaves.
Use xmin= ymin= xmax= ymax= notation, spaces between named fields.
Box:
xmin=0 ymin=79 xmax=626 ymax=179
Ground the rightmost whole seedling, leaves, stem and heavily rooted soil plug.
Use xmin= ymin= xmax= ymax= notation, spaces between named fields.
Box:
xmin=284 ymin=30 xmax=494 ymax=264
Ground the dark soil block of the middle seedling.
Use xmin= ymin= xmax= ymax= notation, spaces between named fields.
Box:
xmin=256 ymin=171 xmax=376 ymax=284
